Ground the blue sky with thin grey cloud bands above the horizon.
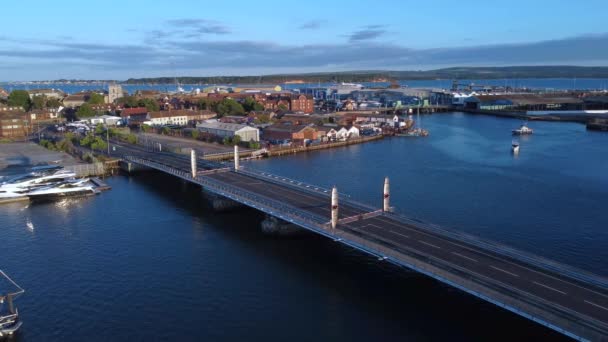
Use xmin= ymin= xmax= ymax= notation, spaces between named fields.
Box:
xmin=0 ymin=0 xmax=608 ymax=81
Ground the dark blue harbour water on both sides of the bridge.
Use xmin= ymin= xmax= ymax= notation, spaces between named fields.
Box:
xmin=0 ymin=113 xmax=608 ymax=341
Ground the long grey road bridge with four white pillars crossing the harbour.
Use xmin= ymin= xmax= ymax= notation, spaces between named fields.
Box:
xmin=112 ymin=142 xmax=608 ymax=341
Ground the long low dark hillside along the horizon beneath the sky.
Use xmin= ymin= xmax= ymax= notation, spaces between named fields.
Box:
xmin=123 ymin=66 xmax=608 ymax=84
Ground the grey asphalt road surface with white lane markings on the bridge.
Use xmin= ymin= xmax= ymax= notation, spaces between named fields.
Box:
xmin=111 ymin=142 xmax=608 ymax=340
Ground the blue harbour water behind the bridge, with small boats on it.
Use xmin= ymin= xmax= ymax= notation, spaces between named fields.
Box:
xmin=246 ymin=113 xmax=608 ymax=276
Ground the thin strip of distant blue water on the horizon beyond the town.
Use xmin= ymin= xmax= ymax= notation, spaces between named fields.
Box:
xmin=0 ymin=78 xmax=608 ymax=94
